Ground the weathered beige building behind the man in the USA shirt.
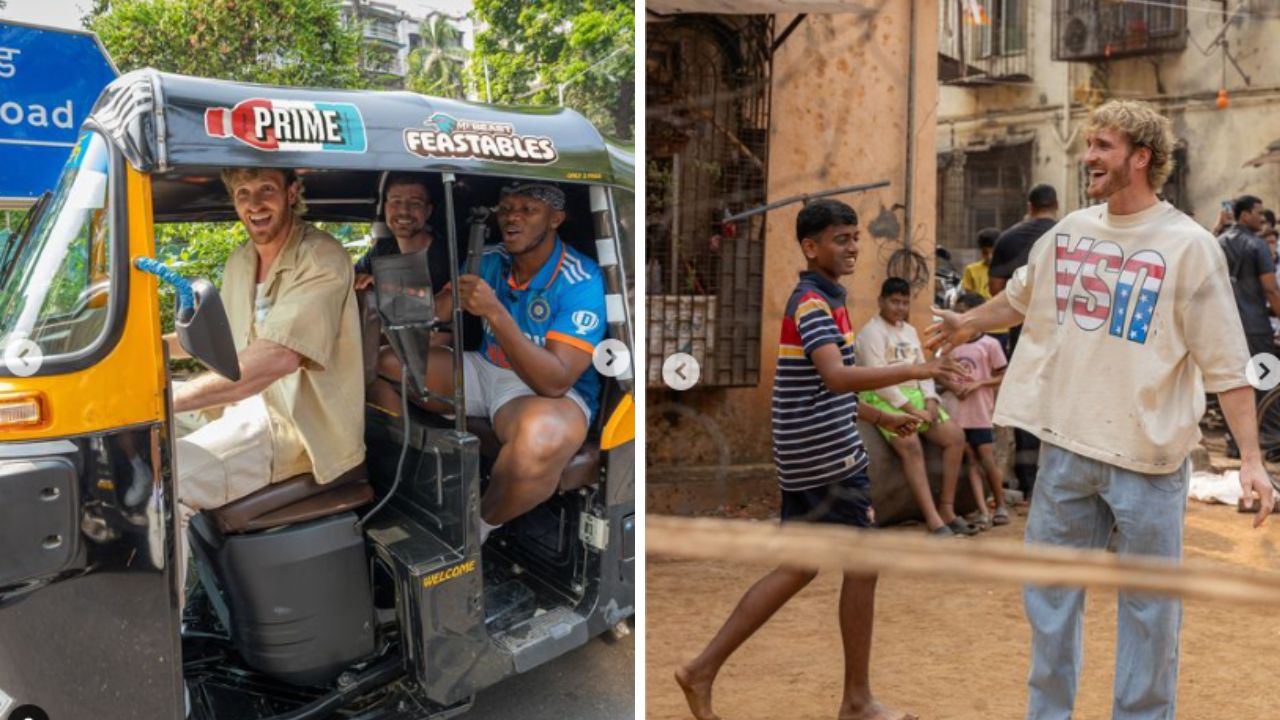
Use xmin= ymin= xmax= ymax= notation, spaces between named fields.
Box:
xmin=937 ymin=0 xmax=1280 ymax=265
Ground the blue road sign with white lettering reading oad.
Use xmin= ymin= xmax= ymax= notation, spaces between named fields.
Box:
xmin=0 ymin=20 xmax=118 ymax=204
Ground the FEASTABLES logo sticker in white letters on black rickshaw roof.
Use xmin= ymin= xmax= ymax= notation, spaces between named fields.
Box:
xmin=404 ymin=113 xmax=557 ymax=165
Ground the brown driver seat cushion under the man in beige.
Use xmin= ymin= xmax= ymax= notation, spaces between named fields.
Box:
xmin=207 ymin=462 xmax=374 ymax=536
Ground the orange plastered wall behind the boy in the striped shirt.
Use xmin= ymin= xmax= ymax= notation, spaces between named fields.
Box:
xmin=646 ymin=0 xmax=937 ymax=466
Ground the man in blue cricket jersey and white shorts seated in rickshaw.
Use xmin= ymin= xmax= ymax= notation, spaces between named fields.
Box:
xmin=371 ymin=183 xmax=605 ymax=539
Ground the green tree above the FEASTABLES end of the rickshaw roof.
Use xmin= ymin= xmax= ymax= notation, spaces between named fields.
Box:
xmin=470 ymin=0 xmax=635 ymax=138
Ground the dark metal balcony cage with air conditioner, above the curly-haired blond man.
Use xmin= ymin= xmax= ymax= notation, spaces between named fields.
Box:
xmin=1053 ymin=0 xmax=1187 ymax=61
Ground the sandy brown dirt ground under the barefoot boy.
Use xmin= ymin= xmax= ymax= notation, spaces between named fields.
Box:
xmin=645 ymin=491 xmax=1280 ymax=720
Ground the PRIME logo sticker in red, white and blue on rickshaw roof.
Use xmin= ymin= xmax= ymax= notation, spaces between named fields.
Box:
xmin=205 ymin=97 xmax=367 ymax=152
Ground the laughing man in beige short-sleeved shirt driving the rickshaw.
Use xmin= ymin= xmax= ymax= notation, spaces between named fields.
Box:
xmin=170 ymin=168 xmax=365 ymax=584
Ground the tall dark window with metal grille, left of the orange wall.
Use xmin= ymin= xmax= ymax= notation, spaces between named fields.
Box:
xmin=645 ymin=15 xmax=773 ymax=387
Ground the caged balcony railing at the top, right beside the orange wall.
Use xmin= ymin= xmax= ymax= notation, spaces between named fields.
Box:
xmin=938 ymin=0 xmax=1032 ymax=85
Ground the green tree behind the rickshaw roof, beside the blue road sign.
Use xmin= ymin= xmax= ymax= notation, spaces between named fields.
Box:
xmin=86 ymin=0 xmax=365 ymax=87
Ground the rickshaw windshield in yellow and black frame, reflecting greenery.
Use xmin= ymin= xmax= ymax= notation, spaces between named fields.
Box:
xmin=0 ymin=132 xmax=115 ymax=360
